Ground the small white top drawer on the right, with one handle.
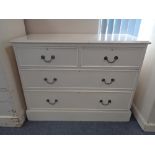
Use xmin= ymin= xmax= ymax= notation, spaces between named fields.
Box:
xmin=81 ymin=47 xmax=145 ymax=67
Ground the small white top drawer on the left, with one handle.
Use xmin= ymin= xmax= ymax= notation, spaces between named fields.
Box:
xmin=15 ymin=48 xmax=78 ymax=67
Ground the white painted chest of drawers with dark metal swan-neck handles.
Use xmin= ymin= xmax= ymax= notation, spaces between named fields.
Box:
xmin=12 ymin=34 xmax=149 ymax=121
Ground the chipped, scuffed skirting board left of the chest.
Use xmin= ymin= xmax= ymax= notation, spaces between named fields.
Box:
xmin=0 ymin=115 xmax=25 ymax=127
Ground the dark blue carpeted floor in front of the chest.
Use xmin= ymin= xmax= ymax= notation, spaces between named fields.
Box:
xmin=0 ymin=116 xmax=155 ymax=135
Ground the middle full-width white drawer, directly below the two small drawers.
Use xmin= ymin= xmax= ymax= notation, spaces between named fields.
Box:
xmin=21 ymin=69 xmax=138 ymax=89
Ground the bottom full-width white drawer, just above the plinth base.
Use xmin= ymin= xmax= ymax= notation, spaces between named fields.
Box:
xmin=25 ymin=91 xmax=133 ymax=110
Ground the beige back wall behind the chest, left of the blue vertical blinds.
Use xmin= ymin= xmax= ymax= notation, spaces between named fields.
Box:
xmin=25 ymin=19 xmax=99 ymax=34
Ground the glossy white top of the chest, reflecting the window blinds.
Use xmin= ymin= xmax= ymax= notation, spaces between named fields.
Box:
xmin=11 ymin=34 xmax=150 ymax=43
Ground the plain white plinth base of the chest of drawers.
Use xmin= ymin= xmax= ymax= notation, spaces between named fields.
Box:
xmin=26 ymin=110 xmax=131 ymax=122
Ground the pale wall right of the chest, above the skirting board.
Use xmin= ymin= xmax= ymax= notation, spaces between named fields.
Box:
xmin=134 ymin=20 xmax=155 ymax=130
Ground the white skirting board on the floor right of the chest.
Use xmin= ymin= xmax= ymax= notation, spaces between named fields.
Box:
xmin=132 ymin=104 xmax=155 ymax=132
